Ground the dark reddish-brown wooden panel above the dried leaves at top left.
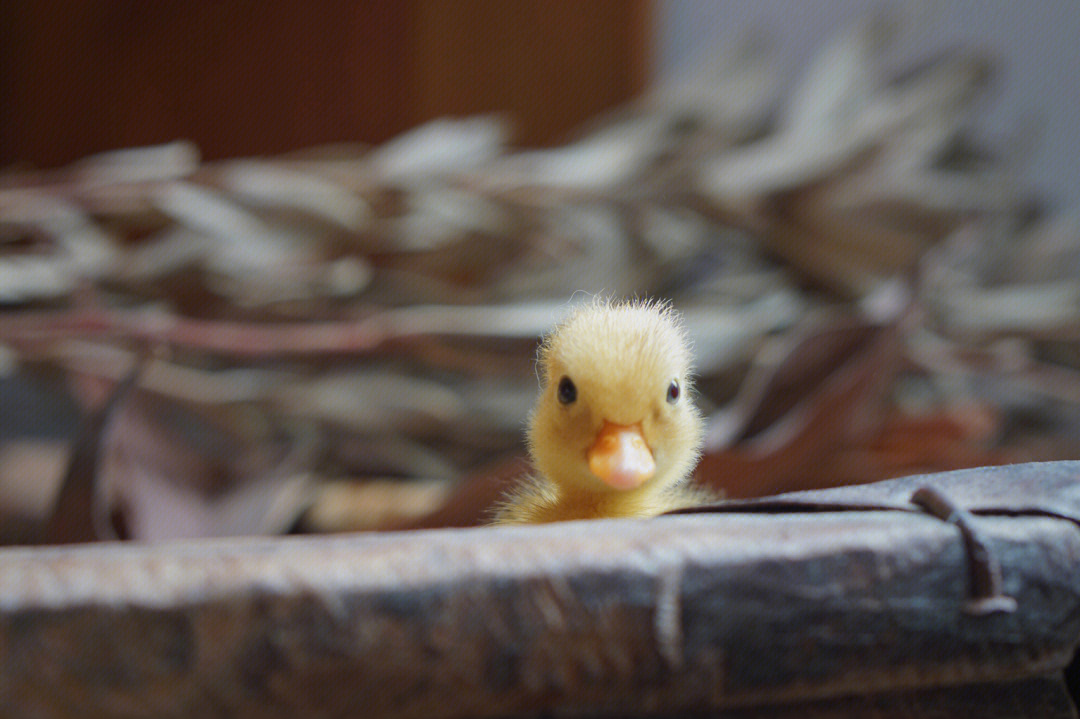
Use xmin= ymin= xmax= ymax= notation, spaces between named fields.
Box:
xmin=0 ymin=0 xmax=651 ymax=166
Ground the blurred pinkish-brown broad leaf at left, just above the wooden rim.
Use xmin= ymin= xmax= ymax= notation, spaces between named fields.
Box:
xmin=96 ymin=386 xmax=319 ymax=540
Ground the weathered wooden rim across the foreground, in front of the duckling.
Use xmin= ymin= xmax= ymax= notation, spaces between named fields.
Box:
xmin=0 ymin=464 xmax=1080 ymax=717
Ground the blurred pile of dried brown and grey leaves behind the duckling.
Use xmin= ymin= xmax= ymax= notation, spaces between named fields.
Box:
xmin=0 ymin=19 xmax=1080 ymax=541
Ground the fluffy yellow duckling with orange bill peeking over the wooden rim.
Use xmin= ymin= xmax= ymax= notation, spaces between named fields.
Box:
xmin=494 ymin=300 xmax=713 ymax=524
